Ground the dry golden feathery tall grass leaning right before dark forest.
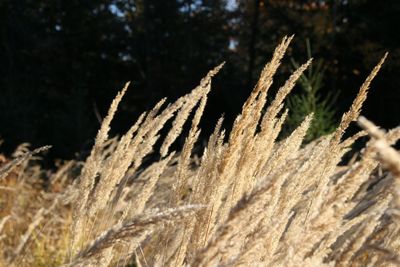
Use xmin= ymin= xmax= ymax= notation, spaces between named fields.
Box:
xmin=0 ymin=37 xmax=400 ymax=266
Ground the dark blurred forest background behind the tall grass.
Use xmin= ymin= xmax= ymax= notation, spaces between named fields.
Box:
xmin=0 ymin=0 xmax=400 ymax=161
